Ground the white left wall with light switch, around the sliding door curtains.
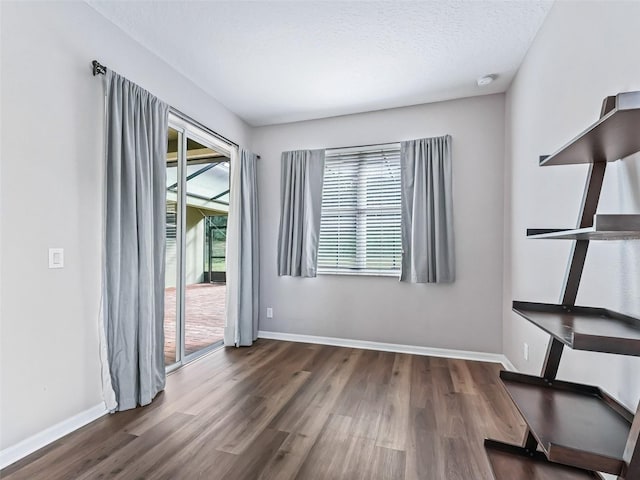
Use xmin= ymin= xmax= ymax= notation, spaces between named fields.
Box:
xmin=0 ymin=2 xmax=250 ymax=449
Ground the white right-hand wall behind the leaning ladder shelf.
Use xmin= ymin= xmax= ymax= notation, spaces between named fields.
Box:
xmin=504 ymin=2 xmax=640 ymax=409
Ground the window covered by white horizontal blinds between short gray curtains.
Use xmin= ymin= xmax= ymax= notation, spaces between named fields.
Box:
xmin=318 ymin=143 xmax=402 ymax=276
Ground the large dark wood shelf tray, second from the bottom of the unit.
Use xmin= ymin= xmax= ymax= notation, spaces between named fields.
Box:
xmin=500 ymin=371 xmax=633 ymax=475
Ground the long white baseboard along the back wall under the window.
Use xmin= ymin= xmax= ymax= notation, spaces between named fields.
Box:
xmin=258 ymin=330 xmax=515 ymax=371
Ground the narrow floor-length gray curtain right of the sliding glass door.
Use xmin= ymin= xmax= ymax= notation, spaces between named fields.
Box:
xmin=236 ymin=149 xmax=260 ymax=346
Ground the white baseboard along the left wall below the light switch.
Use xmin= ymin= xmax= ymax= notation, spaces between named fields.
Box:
xmin=0 ymin=403 xmax=107 ymax=468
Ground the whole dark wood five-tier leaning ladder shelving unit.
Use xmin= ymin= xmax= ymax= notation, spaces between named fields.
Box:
xmin=485 ymin=92 xmax=640 ymax=480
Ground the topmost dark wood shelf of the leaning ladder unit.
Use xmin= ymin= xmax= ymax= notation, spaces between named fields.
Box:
xmin=540 ymin=92 xmax=640 ymax=166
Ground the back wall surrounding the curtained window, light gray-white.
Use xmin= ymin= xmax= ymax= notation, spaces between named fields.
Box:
xmin=253 ymin=95 xmax=504 ymax=352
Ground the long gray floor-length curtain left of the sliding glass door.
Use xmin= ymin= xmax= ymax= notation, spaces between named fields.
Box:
xmin=103 ymin=71 xmax=169 ymax=410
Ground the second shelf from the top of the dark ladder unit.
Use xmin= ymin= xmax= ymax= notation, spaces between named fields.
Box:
xmin=527 ymin=215 xmax=640 ymax=240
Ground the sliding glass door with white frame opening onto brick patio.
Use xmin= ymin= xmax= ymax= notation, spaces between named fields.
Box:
xmin=164 ymin=116 xmax=232 ymax=370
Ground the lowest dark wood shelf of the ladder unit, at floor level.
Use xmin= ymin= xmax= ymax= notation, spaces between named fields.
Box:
xmin=484 ymin=440 xmax=602 ymax=480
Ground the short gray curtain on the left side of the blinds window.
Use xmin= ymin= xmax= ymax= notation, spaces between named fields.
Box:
xmin=278 ymin=150 xmax=324 ymax=277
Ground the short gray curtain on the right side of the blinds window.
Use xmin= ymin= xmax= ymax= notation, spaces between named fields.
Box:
xmin=400 ymin=135 xmax=455 ymax=283
